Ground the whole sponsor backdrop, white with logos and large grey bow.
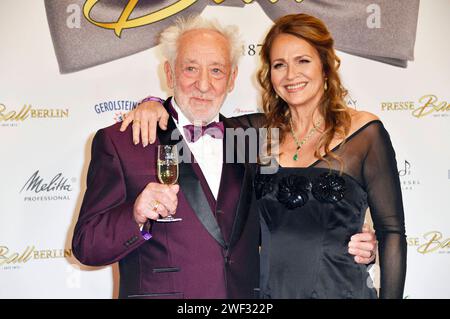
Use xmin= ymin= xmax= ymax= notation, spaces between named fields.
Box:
xmin=0 ymin=0 xmax=450 ymax=298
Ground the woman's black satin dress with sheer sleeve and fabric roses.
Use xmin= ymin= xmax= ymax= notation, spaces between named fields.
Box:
xmin=254 ymin=120 xmax=406 ymax=298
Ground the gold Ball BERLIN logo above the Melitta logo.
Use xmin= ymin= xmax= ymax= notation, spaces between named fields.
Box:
xmin=0 ymin=103 xmax=69 ymax=126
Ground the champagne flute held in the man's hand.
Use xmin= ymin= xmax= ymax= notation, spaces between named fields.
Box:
xmin=156 ymin=145 xmax=182 ymax=223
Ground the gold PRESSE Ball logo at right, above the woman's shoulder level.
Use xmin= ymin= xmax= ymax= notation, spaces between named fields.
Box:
xmin=381 ymin=94 xmax=450 ymax=118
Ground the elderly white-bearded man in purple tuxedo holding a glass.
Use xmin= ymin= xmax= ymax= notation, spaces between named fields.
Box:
xmin=73 ymin=17 xmax=376 ymax=298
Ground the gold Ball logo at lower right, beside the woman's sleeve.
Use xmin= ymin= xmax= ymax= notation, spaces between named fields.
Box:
xmin=407 ymin=230 xmax=450 ymax=255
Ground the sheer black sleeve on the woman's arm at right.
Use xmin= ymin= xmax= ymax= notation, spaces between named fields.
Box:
xmin=362 ymin=122 xmax=406 ymax=299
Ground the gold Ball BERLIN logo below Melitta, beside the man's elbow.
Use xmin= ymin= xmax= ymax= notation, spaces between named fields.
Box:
xmin=0 ymin=244 xmax=72 ymax=270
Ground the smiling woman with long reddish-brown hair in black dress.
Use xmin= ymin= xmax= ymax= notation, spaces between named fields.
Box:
xmin=122 ymin=14 xmax=406 ymax=298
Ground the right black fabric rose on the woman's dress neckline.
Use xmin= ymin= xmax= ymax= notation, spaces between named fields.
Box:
xmin=312 ymin=173 xmax=345 ymax=203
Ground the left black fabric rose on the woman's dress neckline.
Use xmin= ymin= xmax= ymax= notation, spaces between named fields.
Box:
xmin=277 ymin=175 xmax=312 ymax=209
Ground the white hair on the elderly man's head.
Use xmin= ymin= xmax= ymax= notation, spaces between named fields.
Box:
xmin=159 ymin=16 xmax=243 ymax=67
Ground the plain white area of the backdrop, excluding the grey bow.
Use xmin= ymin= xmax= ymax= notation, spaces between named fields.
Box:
xmin=0 ymin=0 xmax=450 ymax=298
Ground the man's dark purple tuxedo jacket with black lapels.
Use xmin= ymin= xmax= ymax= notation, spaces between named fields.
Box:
xmin=72 ymin=102 xmax=259 ymax=299
